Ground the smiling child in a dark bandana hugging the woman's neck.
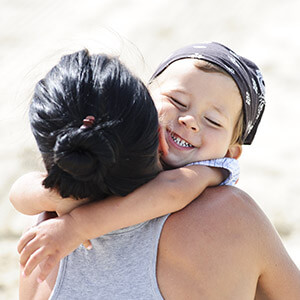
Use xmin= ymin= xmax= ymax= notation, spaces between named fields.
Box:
xmin=11 ymin=43 xmax=265 ymax=281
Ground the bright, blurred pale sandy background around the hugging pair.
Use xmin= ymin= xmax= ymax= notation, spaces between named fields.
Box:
xmin=0 ymin=0 xmax=300 ymax=299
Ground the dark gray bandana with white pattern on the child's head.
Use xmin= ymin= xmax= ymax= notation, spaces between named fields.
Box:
xmin=150 ymin=42 xmax=265 ymax=145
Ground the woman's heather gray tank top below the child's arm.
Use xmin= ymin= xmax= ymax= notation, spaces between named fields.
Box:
xmin=49 ymin=215 xmax=169 ymax=300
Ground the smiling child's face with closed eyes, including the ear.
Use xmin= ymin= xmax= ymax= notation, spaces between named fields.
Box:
xmin=150 ymin=59 xmax=242 ymax=167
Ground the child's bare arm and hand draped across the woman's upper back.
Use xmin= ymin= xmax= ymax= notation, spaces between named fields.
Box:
xmin=18 ymin=166 xmax=223 ymax=280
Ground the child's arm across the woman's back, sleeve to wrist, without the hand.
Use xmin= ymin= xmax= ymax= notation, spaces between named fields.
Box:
xmin=70 ymin=166 xmax=224 ymax=239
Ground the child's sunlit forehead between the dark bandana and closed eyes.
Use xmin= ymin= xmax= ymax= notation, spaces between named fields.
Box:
xmin=153 ymin=59 xmax=242 ymax=119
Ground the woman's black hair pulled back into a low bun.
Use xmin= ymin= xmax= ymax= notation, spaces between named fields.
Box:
xmin=29 ymin=50 xmax=159 ymax=200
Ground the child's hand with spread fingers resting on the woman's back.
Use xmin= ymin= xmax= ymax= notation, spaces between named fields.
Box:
xmin=18 ymin=214 xmax=84 ymax=282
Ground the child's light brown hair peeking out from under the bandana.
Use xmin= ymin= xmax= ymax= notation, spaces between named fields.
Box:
xmin=194 ymin=59 xmax=244 ymax=145
